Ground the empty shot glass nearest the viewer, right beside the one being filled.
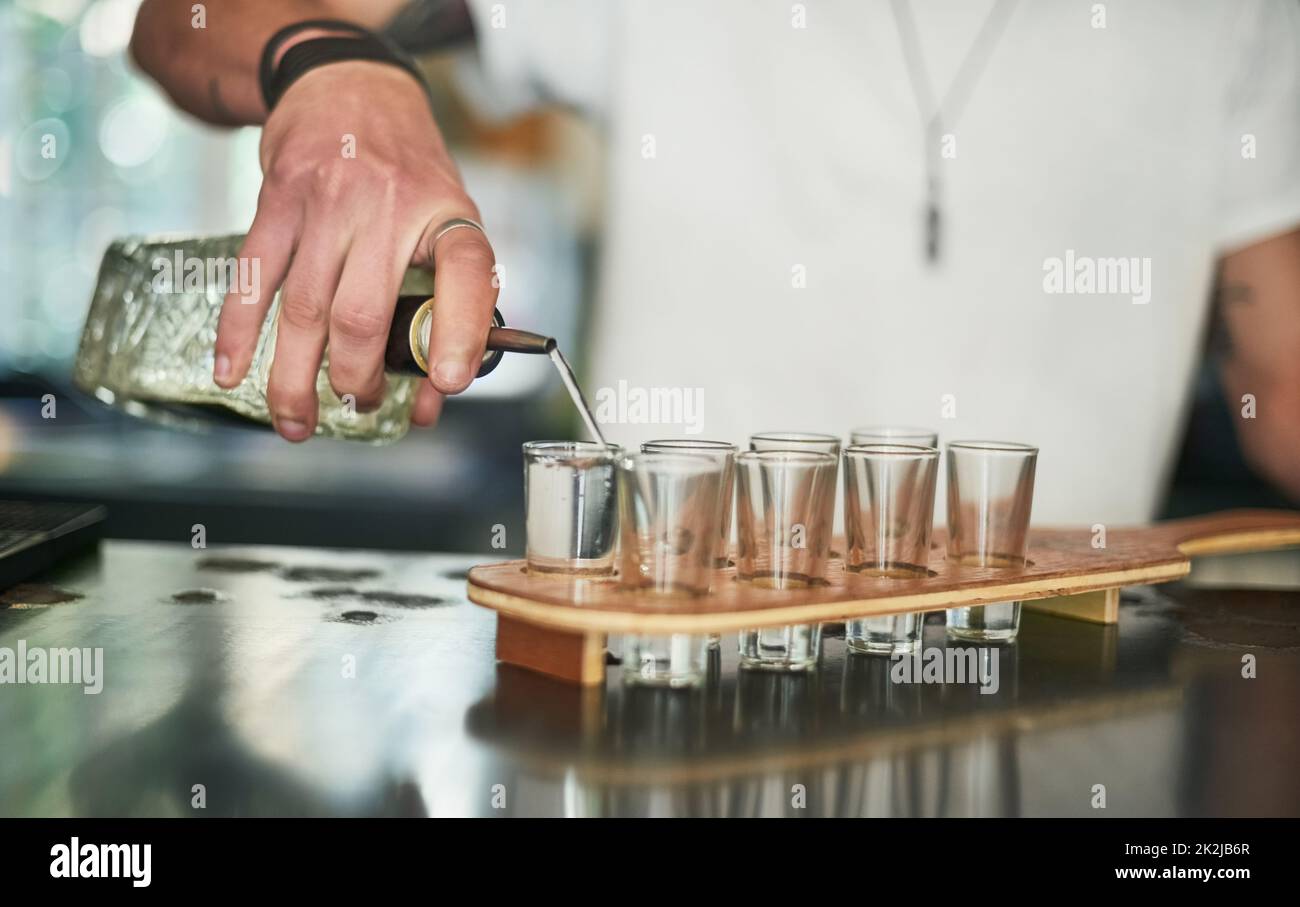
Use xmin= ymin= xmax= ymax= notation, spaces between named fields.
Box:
xmin=618 ymin=454 xmax=725 ymax=687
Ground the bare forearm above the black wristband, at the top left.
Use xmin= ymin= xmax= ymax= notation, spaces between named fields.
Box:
xmin=131 ymin=0 xmax=403 ymax=126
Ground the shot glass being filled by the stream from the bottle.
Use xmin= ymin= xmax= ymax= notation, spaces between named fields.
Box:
xmin=524 ymin=441 xmax=619 ymax=577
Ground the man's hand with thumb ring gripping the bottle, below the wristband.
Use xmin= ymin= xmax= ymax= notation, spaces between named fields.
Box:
xmin=213 ymin=62 xmax=497 ymax=441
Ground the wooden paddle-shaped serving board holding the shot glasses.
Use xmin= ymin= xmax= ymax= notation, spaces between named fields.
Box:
xmin=469 ymin=511 xmax=1300 ymax=683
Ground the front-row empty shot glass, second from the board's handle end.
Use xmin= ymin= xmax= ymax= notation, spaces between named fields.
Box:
xmin=844 ymin=444 xmax=939 ymax=655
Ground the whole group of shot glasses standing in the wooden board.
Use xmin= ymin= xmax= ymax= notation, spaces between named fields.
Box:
xmin=524 ymin=428 xmax=1037 ymax=686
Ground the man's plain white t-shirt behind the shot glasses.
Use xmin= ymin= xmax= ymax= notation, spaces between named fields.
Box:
xmin=473 ymin=0 xmax=1300 ymax=525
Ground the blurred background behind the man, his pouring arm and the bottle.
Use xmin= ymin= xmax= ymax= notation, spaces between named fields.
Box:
xmin=0 ymin=0 xmax=1284 ymax=554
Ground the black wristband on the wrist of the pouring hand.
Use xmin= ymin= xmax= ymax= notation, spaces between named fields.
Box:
xmin=259 ymin=19 xmax=429 ymax=113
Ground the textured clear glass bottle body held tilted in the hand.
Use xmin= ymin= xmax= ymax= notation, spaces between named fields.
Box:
xmin=74 ymin=235 xmax=433 ymax=443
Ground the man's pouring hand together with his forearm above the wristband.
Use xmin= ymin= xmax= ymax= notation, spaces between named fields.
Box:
xmin=131 ymin=0 xmax=497 ymax=441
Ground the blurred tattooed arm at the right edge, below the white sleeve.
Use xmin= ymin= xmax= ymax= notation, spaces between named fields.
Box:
xmin=1219 ymin=231 xmax=1300 ymax=502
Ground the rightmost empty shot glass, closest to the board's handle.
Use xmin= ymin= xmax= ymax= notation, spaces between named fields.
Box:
xmin=948 ymin=441 xmax=1039 ymax=642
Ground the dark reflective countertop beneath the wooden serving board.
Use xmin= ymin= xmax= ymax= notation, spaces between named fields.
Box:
xmin=0 ymin=542 xmax=1300 ymax=816
